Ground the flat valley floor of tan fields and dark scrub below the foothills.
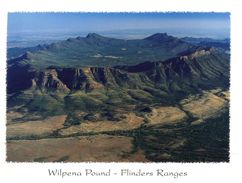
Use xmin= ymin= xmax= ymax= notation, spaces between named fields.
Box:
xmin=7 ymin=89 xmax=229 ymax=162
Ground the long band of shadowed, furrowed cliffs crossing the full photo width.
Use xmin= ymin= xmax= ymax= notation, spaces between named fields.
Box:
xmin=7 ymin=50 xmax=229 ymax=93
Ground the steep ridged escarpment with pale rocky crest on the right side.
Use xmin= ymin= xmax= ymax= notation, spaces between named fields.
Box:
xmin=116 ymin=49 xmax=230 ymax=92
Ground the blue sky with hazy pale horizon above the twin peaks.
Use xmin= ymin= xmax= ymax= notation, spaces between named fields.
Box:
xmin=8 ymin=13 xmax=230 ymax=39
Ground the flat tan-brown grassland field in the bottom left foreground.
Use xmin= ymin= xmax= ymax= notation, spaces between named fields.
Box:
xmin=7 ymin=135 xmax=147 ymax=162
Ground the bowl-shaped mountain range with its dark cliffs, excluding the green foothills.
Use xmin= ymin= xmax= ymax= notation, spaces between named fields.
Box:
xmin=7 ymin=33 xmax=229 ymax=112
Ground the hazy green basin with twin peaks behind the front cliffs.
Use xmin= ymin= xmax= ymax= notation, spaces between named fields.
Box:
xmin=8 ymin=33 xmax=194 ymax=68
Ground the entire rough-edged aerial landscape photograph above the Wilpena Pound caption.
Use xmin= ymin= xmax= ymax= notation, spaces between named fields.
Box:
xmin=6 ymin=12 xmax=230 ymax=163
